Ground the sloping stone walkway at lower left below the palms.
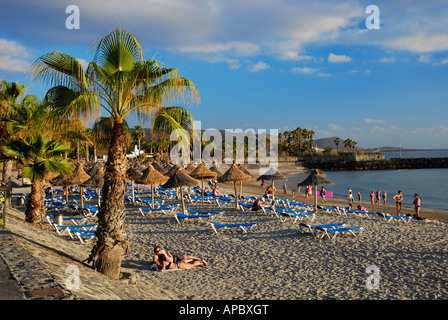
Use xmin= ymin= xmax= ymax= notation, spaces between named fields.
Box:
xmin=0 ymin=208 xmax=176 ymax=300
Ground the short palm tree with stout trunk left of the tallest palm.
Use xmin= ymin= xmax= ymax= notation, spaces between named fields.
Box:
xmin=3 ymin=135 xmax=73 ymax=226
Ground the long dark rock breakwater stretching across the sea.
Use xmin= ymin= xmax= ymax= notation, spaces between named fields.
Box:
xmin=300 ymin=157 xmax=448 ymax=171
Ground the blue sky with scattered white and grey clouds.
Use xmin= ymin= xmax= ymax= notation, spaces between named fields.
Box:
xmin=0 ymin=0 xmax=448 ymax=149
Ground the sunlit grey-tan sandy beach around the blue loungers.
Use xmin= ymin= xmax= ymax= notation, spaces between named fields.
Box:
xmin=0 ymin=164 xmax=448 ymax=301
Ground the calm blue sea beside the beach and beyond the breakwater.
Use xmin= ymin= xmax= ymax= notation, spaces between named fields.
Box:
xmin=286 ymin=149 xmax=448 ymax=214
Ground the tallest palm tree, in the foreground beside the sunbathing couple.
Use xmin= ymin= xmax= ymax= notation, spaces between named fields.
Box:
xmin=32 ymin=28 xmax=199 ymax=279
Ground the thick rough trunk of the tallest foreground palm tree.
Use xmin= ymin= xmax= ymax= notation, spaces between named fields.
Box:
xmin=87 ymin=121 xmax=128 ymax=279
